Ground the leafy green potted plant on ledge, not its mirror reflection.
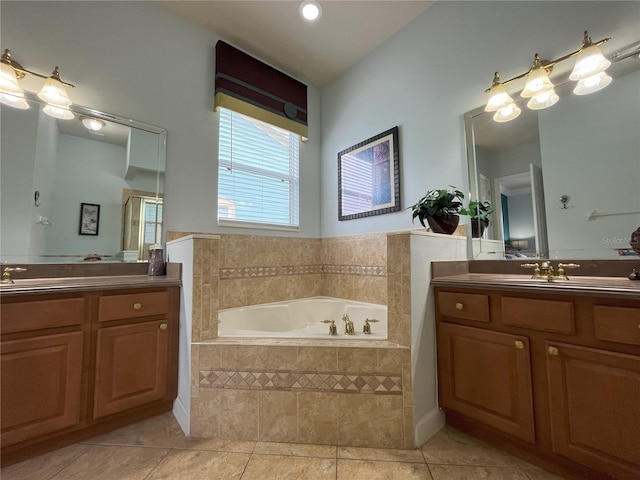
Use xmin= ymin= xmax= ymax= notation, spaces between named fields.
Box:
xmin=408 ymin=185 xmax=464 ymax=235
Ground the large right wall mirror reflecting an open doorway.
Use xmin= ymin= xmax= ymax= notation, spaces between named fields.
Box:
xmin=465 ymin=45 xmax=640 ymax=260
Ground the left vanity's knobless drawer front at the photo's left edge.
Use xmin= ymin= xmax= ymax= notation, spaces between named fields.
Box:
xmin=0 ymin=298 xmax=85 ymax=333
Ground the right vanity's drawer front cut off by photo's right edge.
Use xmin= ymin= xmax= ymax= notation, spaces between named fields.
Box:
xmin=593 ymin=305 xmax=640 ymax=345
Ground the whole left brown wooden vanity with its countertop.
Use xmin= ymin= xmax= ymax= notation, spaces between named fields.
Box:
xmin=0 ymin=275 xmax=180 ymax=465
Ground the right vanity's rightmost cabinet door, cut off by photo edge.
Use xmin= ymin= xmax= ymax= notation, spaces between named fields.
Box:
xmin=547 ymin=342 xmax=640 ymax=479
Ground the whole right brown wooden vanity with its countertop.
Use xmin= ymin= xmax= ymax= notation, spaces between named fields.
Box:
xmin=432 ymin=266 xmax=640 ymax=479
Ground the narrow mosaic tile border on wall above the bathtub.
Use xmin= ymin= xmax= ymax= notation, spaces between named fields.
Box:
xmin=219 ymin=265 xmax=387 ymax=280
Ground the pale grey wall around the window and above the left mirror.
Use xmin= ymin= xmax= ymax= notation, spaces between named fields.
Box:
xmin=0 ymin=1 xmax=320 ymax=237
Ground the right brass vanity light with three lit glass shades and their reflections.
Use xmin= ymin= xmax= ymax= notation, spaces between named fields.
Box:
xmin=485 ymin=30 xmax=611 ymax=122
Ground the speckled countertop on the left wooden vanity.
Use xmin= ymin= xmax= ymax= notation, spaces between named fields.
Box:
xmin=0 ymin=275 xmax=181 ymax=294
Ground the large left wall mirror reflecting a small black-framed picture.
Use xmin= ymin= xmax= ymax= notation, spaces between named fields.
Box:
xmin=0 ymin=95 xmax=166 ymax=263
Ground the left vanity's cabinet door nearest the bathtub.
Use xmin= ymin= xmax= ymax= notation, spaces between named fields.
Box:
xmin=93 ymin=321 xmax=169 ymax=418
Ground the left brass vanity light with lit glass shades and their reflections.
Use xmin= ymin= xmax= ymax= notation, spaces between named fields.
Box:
xmin=0 ymin=49 xmax=74 ymax=120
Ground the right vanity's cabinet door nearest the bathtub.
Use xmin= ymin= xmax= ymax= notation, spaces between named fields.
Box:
xmin=438 ymin=323 xmax=535 ymax=443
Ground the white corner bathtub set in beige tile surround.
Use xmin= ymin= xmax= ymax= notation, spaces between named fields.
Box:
xmin=218 ymin=297 xmax=387 ymax=340
